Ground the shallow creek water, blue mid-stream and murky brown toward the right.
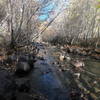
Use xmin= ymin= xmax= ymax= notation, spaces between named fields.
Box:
xmin=15 ymin=44 xmax=100 ymax=100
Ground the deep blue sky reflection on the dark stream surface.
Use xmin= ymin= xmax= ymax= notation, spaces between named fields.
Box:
xmin=31 ymin=59 xmax=68 ymax=100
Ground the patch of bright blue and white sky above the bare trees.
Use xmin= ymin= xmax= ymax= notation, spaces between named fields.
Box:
xmin=38 ymin=0 xmax=68 ymax=21
